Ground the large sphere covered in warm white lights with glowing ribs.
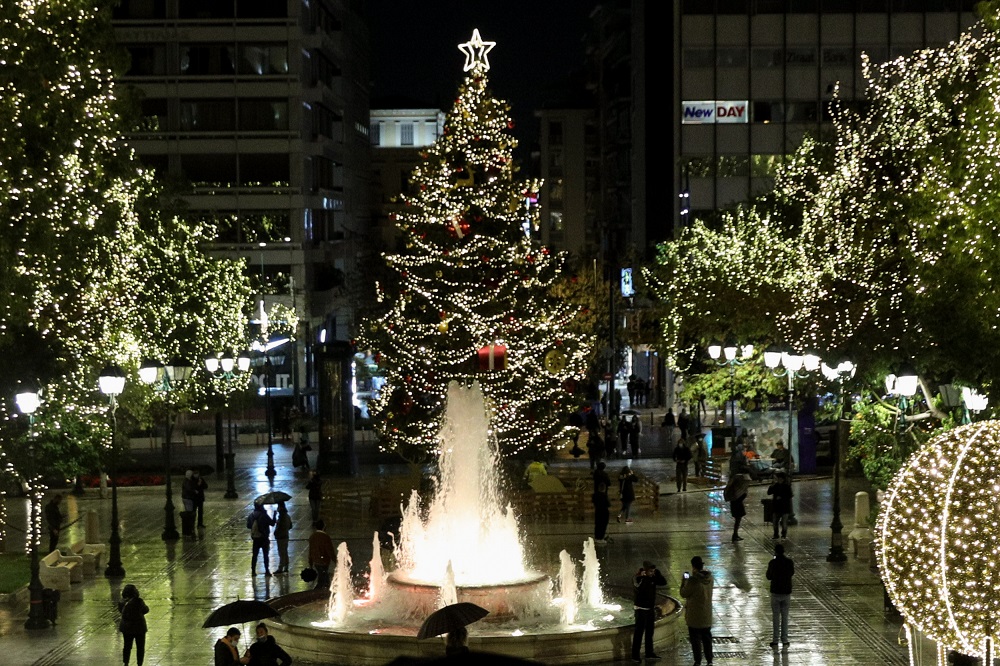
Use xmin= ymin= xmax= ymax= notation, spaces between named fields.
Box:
xmin=876 ymin=421 xmax=1000 ymax=656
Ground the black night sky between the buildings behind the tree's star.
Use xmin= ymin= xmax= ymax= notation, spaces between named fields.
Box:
xmin=367 ymin=0 xmax=597 ymax=149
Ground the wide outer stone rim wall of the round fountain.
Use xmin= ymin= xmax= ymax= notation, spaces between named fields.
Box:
xmin=267 ymin=591 xmax=686 ymax=666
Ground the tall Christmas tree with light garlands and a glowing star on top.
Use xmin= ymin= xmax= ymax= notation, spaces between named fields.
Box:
xmin=362 ymin=30 xmax=590 ymax=458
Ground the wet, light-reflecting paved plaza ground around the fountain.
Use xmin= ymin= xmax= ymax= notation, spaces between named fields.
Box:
xmin=0 ymin=428 xmax=906 ymax=666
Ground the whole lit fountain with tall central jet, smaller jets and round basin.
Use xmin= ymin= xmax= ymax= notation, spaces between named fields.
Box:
xmin=271 ymin=382 xmax=679 ymax=664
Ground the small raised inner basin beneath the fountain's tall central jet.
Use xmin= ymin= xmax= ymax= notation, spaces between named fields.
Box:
xmin=387 ymin=572 xmax=550 ymax=619
